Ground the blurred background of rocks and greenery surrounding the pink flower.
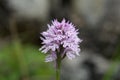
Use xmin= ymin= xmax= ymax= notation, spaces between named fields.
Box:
xmin=0 ymin=0 xmax=120 ymax=80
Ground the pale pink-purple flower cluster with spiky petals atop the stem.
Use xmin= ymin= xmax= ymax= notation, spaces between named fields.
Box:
xmin=39 ymin=19 xmax=82 ymax=62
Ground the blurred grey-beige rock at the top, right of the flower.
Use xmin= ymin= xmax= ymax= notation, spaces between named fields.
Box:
xmin=73 ymin=0 xmax=106 ymax=25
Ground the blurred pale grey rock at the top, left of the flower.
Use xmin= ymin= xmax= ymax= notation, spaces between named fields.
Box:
xmin=8 ymin=0 xmax=50 ymax=20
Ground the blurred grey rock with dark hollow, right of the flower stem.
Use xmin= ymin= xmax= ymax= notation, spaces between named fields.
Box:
xmin=62 ymin=51 xmax=111 ymax=80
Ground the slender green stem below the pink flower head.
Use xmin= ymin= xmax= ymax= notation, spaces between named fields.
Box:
xmin=56 ymin=55 xmax=61 ymax=80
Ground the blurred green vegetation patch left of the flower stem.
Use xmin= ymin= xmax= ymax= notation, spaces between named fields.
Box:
xmin=0 ymin=41 xmax=54 ymax=80
